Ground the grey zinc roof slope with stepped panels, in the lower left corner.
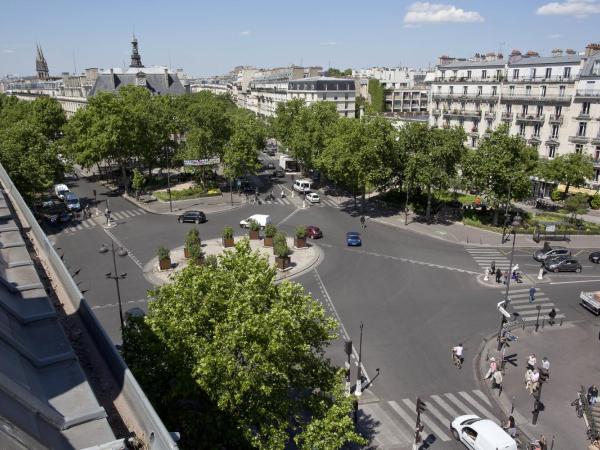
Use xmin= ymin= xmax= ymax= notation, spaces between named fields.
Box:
xmin=0 ymin=191 xmax=119 ymax=450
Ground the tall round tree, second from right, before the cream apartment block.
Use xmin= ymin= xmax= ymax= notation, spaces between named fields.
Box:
xmin=463 ymin=126 xmax=538 ymax=225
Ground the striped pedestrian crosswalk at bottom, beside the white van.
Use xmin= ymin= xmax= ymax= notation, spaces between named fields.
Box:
xmin=361 ymin=389 xmax=500 ymax=448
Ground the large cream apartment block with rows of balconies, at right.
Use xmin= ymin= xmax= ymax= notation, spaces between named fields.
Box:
xmin=429 ymin=44 xmax=600 ymax=181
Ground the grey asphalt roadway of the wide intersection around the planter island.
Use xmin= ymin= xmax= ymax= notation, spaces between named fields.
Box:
xmin=52 ymin=171 xmax=600 ymax=449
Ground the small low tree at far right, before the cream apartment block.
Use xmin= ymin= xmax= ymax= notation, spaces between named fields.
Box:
xmin=540 ymin=153 xmax=594 ymax=195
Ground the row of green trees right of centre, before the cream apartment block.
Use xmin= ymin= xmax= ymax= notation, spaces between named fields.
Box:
xmin=272 ymin=100 xmax=593 ymax=220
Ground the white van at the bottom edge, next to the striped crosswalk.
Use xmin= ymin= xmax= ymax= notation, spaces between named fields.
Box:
xmin=450 ymin=414 xmax=517 ymax=450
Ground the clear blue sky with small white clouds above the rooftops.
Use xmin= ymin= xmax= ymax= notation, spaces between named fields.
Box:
xmin=0 ymin=0 xmax=600 ymax=76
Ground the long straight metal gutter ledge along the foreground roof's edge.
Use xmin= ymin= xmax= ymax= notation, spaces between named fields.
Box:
xmin=0 ymin=164 xmax=178 ymax=450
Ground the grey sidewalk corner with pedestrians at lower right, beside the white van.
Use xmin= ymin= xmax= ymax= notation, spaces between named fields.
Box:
xmin=477 ymin=321 xmax=600 ymax=450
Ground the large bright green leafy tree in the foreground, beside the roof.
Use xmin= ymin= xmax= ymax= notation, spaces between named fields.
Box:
xmin=123 ymin=240 xmax=364 ymax=449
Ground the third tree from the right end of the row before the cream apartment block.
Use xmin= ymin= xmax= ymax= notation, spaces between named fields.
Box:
xmin=399 ymin=123 xmax=466 ymax=221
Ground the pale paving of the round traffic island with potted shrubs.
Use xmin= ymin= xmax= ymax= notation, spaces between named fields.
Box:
xmin=144 ymin=236 xmax=323 ymax=286
